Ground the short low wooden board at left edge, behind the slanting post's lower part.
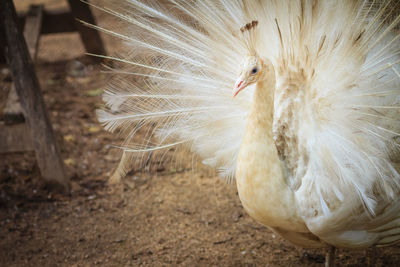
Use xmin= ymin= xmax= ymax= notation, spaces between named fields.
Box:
xmin=0 ymin=123 xmax=33 ymax=153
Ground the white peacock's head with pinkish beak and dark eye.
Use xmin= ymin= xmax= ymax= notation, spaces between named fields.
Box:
xmin=232 ymin=55 xmax=273 ymax=97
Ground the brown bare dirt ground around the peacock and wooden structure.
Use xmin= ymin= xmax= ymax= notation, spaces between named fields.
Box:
xmin=0 ymin=0 xmax=400 ymax=266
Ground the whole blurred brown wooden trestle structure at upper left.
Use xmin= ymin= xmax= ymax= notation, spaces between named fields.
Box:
xmin=0 ymin=0 xmax=105 ymax=193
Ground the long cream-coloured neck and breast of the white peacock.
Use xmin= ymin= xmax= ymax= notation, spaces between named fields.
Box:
xmin=236 ymin=77 xmax=306 ymax=232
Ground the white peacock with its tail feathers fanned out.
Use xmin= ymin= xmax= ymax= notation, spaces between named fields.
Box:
xmin=94 ymin=0 xmax=400 ymax=266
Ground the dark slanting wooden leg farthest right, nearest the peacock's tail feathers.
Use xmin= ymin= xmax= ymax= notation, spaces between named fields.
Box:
xmin=68 ymin=0 xmax=106 ymax=56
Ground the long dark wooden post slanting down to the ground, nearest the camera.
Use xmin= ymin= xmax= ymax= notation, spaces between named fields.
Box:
xmin=0 ymin=0 xmax=69 ymax=189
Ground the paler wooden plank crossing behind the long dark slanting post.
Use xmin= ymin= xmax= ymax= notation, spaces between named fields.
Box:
xmin=3 ymin=5 xmax=43 ymax=125
